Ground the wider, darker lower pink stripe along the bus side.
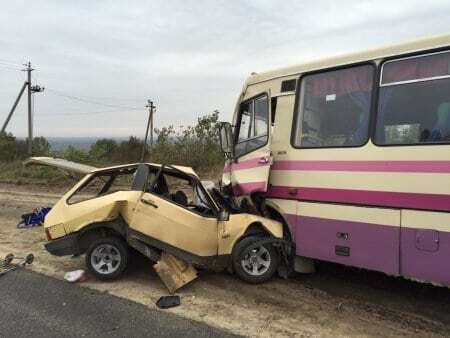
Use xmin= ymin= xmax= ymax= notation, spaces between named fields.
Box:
xmin=267 ymin=186 xmax=450 ymax=211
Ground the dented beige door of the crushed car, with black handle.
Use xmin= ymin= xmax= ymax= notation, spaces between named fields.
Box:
xmin=131 ymin=173 xmax=218 ymax=256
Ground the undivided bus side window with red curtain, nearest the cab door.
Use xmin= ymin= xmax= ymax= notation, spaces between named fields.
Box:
xmin=294 ymin=65 xmax=374 ymax=148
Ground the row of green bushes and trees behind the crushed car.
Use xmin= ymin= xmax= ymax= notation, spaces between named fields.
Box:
xmin=0 ymin=112 xmax=223 ymax=179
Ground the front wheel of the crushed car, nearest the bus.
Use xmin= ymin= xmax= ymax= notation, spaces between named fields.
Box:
xmin=232 ymin=236 xmax=280 ymax=284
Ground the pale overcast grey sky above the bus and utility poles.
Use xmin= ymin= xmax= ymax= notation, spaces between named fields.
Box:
xmin=0 ymin=0 xmax=450 ymax=137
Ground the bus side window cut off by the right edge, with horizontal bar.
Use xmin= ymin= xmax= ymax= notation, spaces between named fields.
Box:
xmin=375 ymin=51 xmax=450 ymax=145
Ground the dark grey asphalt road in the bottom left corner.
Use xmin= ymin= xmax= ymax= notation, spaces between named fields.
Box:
xmin=0 ymin=270 xmax=239 ymax=338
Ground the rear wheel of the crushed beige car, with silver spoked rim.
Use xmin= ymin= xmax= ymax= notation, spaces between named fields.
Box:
xmin=85 ymin=237 xmax=128 ymax=280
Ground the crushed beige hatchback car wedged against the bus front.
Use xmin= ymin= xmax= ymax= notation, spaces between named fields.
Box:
xmin=44 ymin=163 xmax=292 ymax=283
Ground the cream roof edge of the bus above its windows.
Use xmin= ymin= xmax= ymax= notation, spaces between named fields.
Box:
xmin=247 ymin=34 xmax=450 ymax=85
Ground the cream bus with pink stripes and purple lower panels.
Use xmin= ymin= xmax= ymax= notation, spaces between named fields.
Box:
xmin=221 ymin=35 xmax=450 ymax=285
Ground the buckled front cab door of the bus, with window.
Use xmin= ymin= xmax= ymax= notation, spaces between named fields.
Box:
xmin=224 ymin=93 xmax=272 ymax=195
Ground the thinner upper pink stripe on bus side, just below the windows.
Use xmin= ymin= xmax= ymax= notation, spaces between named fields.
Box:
xmin=272 ymin=160 xmax=450 ymax=173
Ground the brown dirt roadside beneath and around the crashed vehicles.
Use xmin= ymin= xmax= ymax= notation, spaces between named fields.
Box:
xmin=0 ymin=184 xmax=450 ymax=337
